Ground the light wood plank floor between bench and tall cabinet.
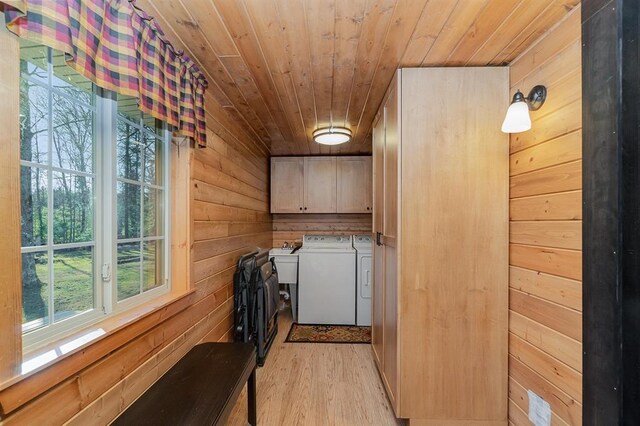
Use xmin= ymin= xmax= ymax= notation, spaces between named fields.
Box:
xmin=228 ymin=309 xmax=402 ymax=426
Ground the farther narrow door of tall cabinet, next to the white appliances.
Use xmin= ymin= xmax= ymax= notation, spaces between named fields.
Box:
xmin=371 ymin=114 xmax=384 ymax=372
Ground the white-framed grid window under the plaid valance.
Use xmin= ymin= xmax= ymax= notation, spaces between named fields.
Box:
xmin=20 ymin=40 xmax=170 ymax=348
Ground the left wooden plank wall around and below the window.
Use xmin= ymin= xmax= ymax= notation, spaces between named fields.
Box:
xmin=0 ymin=72 xmax=272 ymax=426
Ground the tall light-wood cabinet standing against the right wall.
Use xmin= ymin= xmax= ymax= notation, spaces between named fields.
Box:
xmin=372 ymin=67 xmax=509 ymax=425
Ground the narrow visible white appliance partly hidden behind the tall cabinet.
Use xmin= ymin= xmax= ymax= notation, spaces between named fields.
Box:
xmin=353 ymin=235 xmax=373 ymax=326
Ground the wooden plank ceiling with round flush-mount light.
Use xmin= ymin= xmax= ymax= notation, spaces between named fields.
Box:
xmin=137 ymin=0 xmax=579 ymax=155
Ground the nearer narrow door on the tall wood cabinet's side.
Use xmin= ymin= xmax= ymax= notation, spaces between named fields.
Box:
xmin=383 ymin=79 xmax=400 ymax=406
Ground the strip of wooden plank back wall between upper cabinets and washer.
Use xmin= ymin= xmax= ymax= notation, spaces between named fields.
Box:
xmin=273 ymin=213 xmax=371 ymax=247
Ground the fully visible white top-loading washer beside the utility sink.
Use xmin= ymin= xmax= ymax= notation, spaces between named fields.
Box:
xmin=298 ymin=235 xmax=356 ymax=325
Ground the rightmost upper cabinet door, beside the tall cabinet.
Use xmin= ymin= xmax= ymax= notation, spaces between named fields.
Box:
xmin=337 ymin=157 xmax=372 ymax=213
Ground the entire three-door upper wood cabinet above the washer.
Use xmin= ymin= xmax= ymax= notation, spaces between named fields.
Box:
xmin=271 ymin=156 xmax=373 ymax=213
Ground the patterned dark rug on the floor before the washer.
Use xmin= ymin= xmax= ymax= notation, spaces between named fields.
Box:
xmin=285 ymin=323 xmax=371 ymax=343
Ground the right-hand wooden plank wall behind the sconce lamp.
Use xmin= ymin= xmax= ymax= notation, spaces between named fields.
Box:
xmin=509 ymin=7 xmax=582 ymax=425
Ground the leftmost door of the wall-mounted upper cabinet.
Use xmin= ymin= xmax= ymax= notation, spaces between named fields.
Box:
xmin=271 ymin=157 xmax=304 ymax=213
